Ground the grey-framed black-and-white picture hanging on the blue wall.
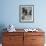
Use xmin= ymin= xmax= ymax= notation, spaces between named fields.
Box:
xmin=19 ymin=5 xmax=34 ymax=22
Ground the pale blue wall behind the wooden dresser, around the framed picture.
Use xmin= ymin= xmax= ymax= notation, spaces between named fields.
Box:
xmin=0 ymin=0 xmax=46 ymax=28
